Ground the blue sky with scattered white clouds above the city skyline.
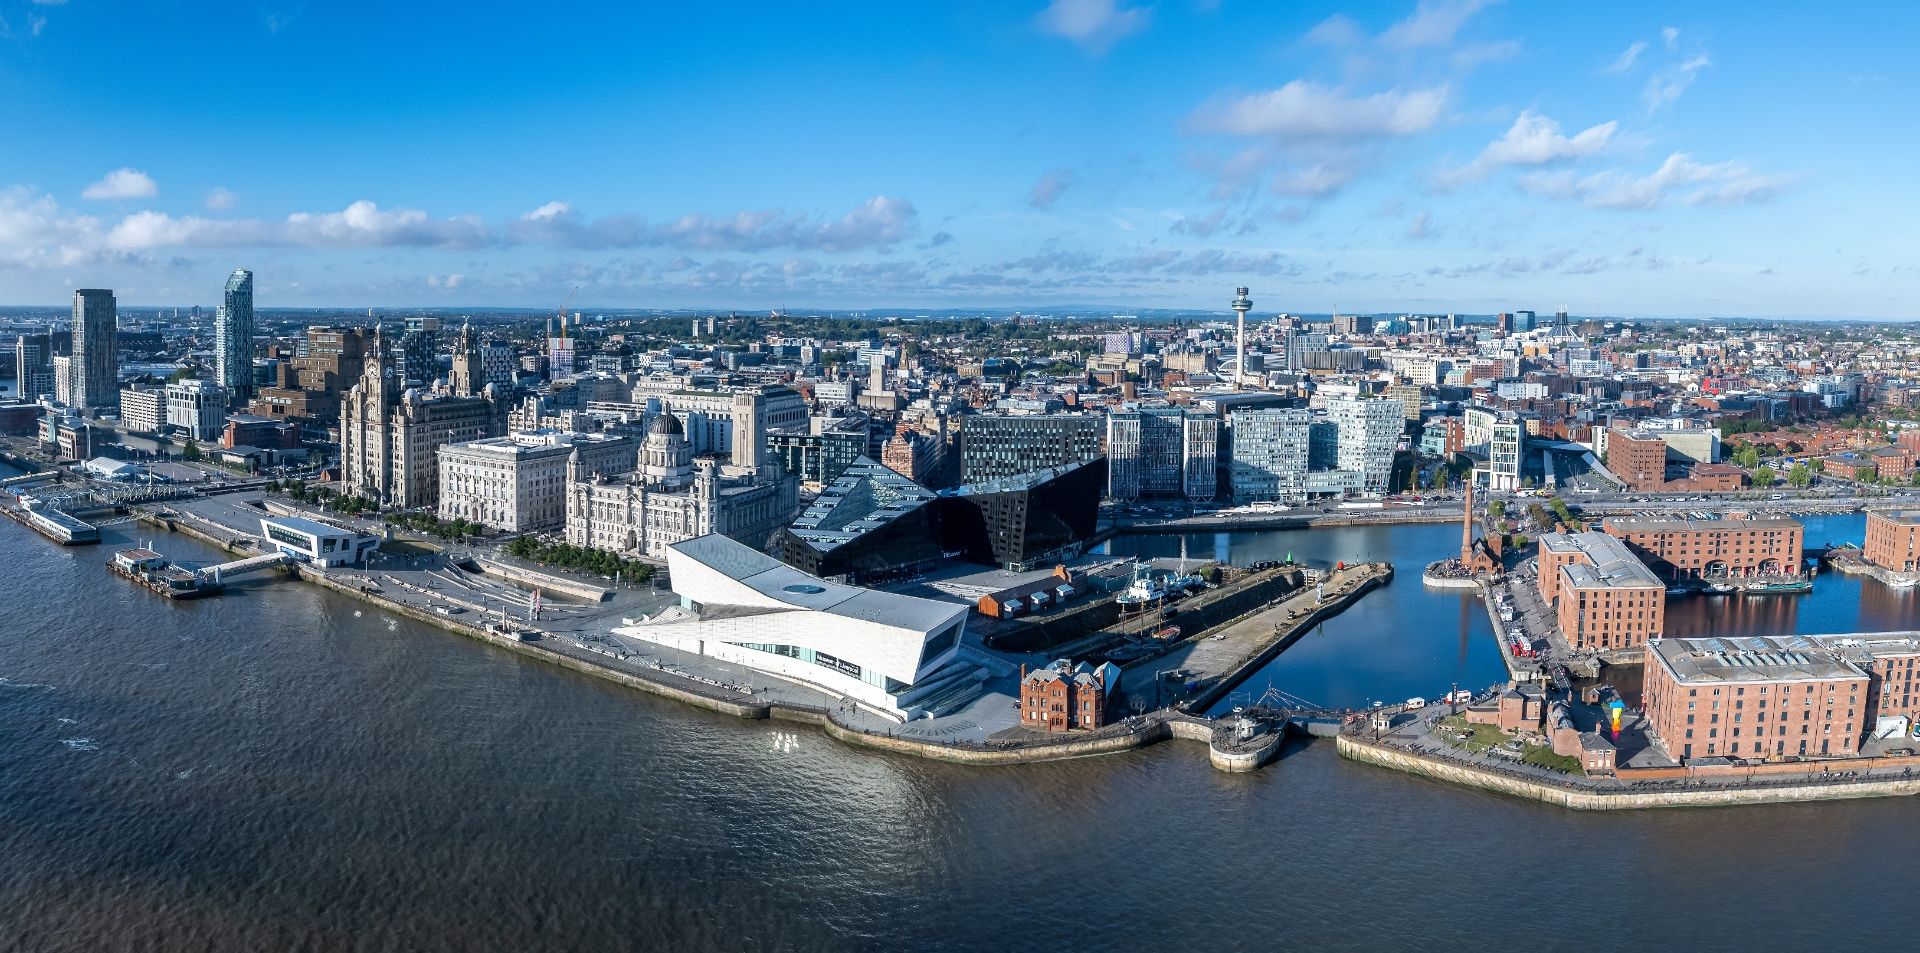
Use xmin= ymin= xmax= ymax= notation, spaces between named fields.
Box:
xmin=0 ymin=0 xmax=1920 ymax=317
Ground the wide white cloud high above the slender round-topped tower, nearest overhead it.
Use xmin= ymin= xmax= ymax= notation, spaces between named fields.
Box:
xmin=1192 ymin=79 xmax=1453 ymax=140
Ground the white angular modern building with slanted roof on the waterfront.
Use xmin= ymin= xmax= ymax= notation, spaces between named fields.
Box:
xmin=614 ymin=534 xmax=981 ymax=721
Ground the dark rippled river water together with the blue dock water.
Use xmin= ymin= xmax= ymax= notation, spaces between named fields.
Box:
xmin=0 ymin=503 xmax=1920 ymax=951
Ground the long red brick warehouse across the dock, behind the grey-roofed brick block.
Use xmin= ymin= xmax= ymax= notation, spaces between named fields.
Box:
xmin=1601 ymin=515 xmax=1807 ymax=580
